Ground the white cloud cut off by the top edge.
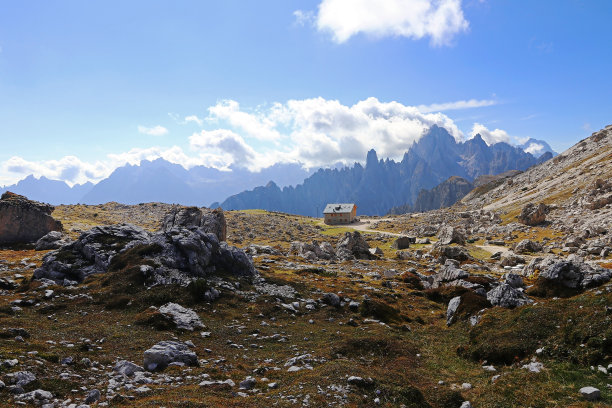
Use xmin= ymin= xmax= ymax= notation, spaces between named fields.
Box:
xmin=314 ymin=0 xmax=469 ymax=46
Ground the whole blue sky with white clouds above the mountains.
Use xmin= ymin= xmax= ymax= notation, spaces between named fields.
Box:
xmin=0 ymin=0 xmax=612 ymax=185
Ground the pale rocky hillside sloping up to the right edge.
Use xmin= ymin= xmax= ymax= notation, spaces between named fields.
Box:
xmin=461 ymin=125 xmax=612 ymax=231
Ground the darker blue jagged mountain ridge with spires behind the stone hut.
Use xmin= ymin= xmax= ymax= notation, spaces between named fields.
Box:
xmin=220 ymin=125 xmax=552 ymax=216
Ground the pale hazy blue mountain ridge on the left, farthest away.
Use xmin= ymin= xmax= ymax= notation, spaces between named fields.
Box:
xmin=0 ymin=159 xmax=311 ymax=206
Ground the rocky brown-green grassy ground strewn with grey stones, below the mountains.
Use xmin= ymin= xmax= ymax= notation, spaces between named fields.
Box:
xmin=0 ymin=126 xmax=612 ymax=408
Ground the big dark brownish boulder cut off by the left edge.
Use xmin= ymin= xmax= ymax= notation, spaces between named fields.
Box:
xmin=0 ymin=191 xmax=63 ymax=245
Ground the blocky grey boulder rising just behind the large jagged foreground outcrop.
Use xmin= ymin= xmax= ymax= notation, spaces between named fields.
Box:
xmin=162 ymin=207 xmax=227 ymax=242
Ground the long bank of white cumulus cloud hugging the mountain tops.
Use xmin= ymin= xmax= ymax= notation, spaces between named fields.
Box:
xmin=0 ymin=97 xmax=510 ymax=185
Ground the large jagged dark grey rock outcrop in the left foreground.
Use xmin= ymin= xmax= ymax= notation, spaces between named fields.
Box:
xmin=34 ymin=207 xmax=256 ymax=286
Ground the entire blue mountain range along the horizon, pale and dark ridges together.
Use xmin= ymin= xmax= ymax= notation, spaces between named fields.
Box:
xmin=0 ymin=126 xmax=554 ymax=212
